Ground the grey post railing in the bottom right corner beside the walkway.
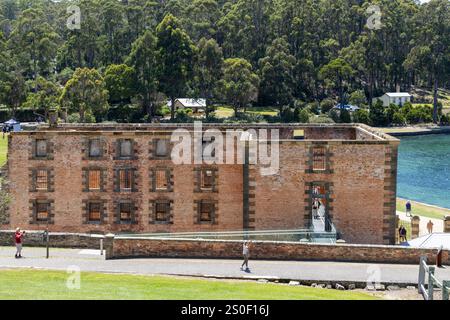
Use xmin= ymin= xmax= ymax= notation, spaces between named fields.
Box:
xmin=418 ymin=256 xmax=450 ymax=300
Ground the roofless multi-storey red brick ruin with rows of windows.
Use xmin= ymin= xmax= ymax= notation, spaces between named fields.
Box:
xmin=0 ymin=124 xmax=399 ymax=244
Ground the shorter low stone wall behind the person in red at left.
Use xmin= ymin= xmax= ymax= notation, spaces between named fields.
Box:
xmin=0 ymin=230 xmax=104 ymax=249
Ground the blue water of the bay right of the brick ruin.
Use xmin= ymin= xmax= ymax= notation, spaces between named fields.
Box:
xmin=397 ymin=134 xmax=450 ymax=209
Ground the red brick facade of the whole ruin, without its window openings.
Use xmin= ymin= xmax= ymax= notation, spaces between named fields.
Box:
xmin=0 ymin=126 xmax=398 ymax=244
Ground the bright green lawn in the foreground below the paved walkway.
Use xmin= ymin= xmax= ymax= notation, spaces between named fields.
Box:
xmin=0 ymin=270 xmax=376 ymax=300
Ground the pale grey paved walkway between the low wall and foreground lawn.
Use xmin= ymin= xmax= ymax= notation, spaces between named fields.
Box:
xmin=0 ymin=247 xmax=450 ymax=284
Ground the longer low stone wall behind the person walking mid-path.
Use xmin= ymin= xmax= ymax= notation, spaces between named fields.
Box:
xmin=105 ymin=236 xmax=450 ymax=264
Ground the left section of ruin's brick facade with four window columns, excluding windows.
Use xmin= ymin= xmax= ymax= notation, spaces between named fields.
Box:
xmin=4 ymin=133 xmax=243 ymax=232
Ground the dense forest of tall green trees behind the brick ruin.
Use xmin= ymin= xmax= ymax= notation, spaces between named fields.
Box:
xmin=0 ymin=0 xmax=450 ymax=124
